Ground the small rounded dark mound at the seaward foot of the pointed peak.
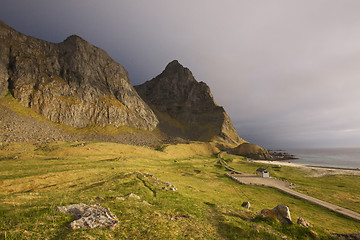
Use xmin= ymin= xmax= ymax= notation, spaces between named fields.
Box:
xmin=230 ymin=143 xmax=272 ymax=160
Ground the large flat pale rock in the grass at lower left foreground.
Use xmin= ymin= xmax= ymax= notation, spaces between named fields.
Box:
xmin=55 ymin=203 xmax=119 ymax=229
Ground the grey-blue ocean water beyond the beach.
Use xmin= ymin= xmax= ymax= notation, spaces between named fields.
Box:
xmin=286 ymin=148 xmax=360 ymax=169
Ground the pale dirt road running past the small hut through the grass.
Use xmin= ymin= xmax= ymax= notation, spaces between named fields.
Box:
xmin=219 ymin=153 xmax=360 ymax=222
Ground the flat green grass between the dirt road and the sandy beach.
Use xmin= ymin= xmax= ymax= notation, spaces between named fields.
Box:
xmin=225 ymin=155 xmax=360 ymax=213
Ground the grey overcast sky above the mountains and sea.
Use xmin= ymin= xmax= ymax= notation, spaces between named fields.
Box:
xmin=0 ymin=0 xmax=360 ymax=148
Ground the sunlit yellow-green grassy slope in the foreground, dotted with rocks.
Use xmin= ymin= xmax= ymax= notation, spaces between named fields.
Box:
xmin=0 ymin=142 xmax=360 ymax=239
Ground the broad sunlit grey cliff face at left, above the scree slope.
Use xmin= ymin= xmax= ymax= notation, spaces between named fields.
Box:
xmin=0 ymin=21 xmax=158 ymax=130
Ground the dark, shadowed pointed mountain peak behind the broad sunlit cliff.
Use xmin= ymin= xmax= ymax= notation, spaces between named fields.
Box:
xmin=135 ymin=60 xmax=243 ymax=145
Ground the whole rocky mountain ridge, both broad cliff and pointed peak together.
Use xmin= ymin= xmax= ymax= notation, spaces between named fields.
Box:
xmin=0 ymin=20 xmax=245 ymax=147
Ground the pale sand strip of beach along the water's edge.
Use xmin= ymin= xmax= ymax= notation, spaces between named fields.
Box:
xmin=251 ymin=160 xmax=360 ymax=177
